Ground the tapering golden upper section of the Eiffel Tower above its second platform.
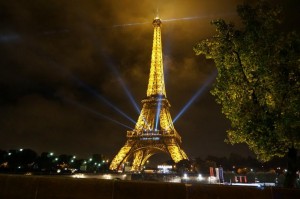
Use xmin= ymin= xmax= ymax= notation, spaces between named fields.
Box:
xmin=147 ymin=17 xmax=166 ymax=97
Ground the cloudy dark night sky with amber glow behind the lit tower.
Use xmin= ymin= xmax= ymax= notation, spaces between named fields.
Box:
xmin=0 ymin=0 xmax=298 ymax=162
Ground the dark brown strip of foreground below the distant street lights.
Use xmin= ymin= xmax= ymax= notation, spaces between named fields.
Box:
xmin=0 ymin=175 xmax=300 ymax=199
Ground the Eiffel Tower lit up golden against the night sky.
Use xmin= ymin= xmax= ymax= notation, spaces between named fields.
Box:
xmin=109 ymin=17 xmax=188 ymax=171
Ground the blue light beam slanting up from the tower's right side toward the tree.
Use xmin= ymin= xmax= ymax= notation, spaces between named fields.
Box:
xmin=173 ymin=71 xmax=217 ymax=123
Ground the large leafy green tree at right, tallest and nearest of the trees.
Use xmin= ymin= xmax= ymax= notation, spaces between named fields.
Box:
xmin=194 ymin=1 xmax=300 ymax=187
